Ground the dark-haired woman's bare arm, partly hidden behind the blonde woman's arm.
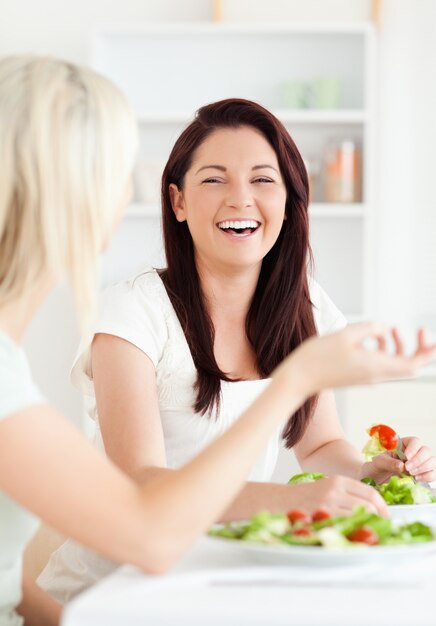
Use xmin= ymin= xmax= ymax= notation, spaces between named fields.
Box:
xmin=92 ymin=334 xmax=386 ymax=521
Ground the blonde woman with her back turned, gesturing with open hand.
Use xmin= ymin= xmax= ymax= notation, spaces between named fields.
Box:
xmin=0 ymin=57 xmax=436 ymax=626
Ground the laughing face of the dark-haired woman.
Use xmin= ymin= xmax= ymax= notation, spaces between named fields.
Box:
xmin=170 ymin=126 xmax=286 ymax=268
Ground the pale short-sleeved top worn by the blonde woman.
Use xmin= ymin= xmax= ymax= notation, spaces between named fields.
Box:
xmin=0 ymin=333 xmax=46 ymax=626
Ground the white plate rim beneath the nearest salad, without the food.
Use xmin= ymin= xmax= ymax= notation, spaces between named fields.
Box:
xmin=210 ymin=537 xmax=436 ymax=567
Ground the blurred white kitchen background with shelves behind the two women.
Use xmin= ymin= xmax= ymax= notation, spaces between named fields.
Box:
xmin=0 ymin=0 xmax=436 ymax=479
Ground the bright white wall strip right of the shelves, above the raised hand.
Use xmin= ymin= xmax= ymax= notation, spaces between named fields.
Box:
xmin=377 ymin=0 xmax=436 ymax=337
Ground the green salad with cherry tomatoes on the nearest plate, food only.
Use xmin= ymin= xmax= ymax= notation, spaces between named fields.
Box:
xmin=209 ymin=506 xmax=435 ymax=548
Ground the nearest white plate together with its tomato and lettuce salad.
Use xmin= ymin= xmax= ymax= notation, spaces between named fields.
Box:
xmin=209 ymin=506 xmax=436 ymax=567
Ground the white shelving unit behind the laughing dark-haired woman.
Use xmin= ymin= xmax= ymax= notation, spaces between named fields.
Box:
xmin=92 ymin=23 xmax=375 ymax=318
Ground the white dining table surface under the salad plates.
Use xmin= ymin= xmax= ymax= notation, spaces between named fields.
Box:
xmin=61 ymin=529 xmax=436 ymax=626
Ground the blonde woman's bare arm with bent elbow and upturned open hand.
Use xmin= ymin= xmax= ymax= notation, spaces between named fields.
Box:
xmin=0 ymin=324 xmax=436 ymax=573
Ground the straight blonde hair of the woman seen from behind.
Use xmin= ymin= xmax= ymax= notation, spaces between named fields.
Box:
xmin=0 ymin=56 xmax=138 ymax=329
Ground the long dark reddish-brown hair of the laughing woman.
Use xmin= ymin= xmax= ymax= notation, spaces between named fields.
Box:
xmin=161 ymin=98 xmax=316 ymax=448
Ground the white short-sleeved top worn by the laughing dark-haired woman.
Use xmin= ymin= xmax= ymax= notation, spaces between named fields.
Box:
xmin=38 ymin=269 xmax=345 ymax=604
